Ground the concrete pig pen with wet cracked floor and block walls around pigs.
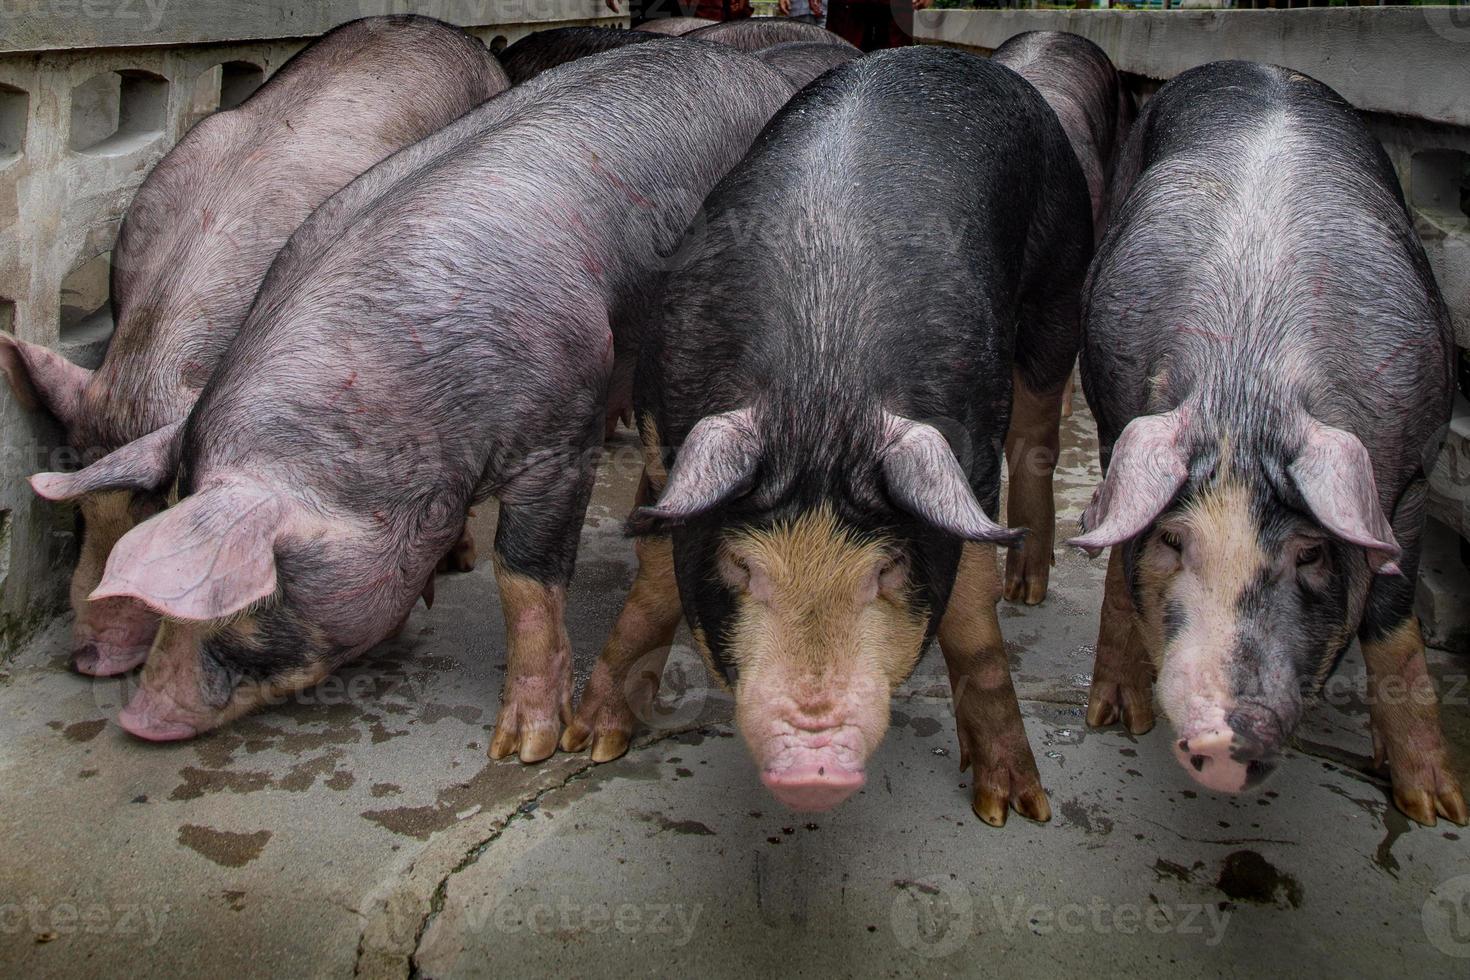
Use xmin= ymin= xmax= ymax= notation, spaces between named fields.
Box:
xmin=0 ymin=0 xmax=1470 ymax=977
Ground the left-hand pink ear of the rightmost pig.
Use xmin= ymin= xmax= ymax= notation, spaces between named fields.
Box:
xmin=1067 ymin=410 xmax=1189 ymax=557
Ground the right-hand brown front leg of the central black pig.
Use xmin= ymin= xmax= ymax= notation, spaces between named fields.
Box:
xmin=939 ymin=544 xmax=1051 ymax=827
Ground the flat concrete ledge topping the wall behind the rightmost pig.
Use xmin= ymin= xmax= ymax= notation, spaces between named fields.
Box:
xmin=914 ymin=7 xmax=1470 ymax=126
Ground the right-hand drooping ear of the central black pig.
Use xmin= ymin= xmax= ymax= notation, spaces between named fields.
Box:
xmin=882 ymin=414 xmax=1026 ymax=547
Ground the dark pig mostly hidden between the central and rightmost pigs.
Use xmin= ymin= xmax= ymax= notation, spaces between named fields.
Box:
xmin=991 ymin=31 xmax=1136 ymax=239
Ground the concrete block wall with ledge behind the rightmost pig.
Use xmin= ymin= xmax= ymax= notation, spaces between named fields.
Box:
xmin=914 ymin=7 xmax=1470 ymax=538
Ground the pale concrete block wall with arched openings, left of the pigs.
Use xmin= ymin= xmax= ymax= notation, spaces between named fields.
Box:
xmin=0 ymin=0 xmax=628 ymax=661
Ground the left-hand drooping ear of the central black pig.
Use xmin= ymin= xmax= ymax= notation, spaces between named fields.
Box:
xmin=629 ymin=408 xmax=760 ymax=533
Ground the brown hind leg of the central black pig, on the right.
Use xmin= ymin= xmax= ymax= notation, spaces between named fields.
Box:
xmin=1005 ymin=370 xmax=1066 ymax=605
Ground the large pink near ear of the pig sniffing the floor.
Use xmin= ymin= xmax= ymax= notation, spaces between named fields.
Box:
xmin=88 ymin=486 xmax=288 ymax=621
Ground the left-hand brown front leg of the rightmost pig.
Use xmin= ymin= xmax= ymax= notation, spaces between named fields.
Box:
xmin=1088 ymin=548 xmax=1154 ymax=735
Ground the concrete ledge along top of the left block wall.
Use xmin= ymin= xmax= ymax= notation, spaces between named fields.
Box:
xmin=0 ymin=0 xmax=628 ymax=54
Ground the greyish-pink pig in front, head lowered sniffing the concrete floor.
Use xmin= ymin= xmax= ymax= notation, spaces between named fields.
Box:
xmin=28 ymin=38 xmax=791 ymax=743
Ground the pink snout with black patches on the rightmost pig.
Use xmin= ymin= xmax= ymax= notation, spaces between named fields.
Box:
xmin=1175 ymin=702 xmax=1286 ymax=793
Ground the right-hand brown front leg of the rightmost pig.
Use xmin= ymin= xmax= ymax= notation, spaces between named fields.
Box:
xmin=1363 ymin=620 xmax=1470 ymax=827
